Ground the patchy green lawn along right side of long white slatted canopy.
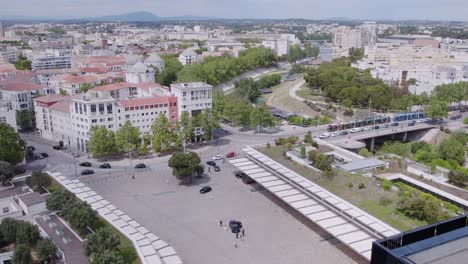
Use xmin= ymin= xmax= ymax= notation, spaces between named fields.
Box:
xmin=257 ymin=146 xmax=428 ymax=231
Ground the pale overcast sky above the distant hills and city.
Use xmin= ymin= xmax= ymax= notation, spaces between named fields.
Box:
xmin=0 ymin=0 xmax=468 ymax=20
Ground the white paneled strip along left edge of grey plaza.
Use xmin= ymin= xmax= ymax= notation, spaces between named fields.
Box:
xmin=47 ymin=172 xmax=183 ymax=264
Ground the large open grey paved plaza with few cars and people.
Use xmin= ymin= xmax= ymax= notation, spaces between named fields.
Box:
xmin=81 ymin=158 xmax=354 ymax=264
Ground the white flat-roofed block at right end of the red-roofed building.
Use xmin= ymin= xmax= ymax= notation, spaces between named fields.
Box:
xmin=171 ymin=82 xmax=213 ymax=116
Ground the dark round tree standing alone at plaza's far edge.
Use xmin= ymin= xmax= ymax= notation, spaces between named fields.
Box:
xmin=169 ymin=152 xmax=200 ymax=181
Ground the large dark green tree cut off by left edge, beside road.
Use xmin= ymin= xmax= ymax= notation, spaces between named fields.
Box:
xmin=0 ymin=123 xmax=25 ymax=165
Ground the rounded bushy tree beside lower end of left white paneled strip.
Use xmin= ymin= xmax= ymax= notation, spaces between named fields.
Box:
xmin=84 ymin=228 xmax=120 ymax=256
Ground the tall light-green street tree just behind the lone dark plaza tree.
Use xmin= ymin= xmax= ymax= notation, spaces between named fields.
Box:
xmin=151 ymin=113 xmax=177 ymax=152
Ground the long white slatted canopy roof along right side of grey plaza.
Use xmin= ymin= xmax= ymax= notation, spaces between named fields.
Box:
xmin=230 ymin=147 xmax=399 ymax=260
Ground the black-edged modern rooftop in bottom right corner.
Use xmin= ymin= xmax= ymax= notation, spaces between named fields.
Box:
xmin=371 ymin=215 xmax=468 ymax=264
